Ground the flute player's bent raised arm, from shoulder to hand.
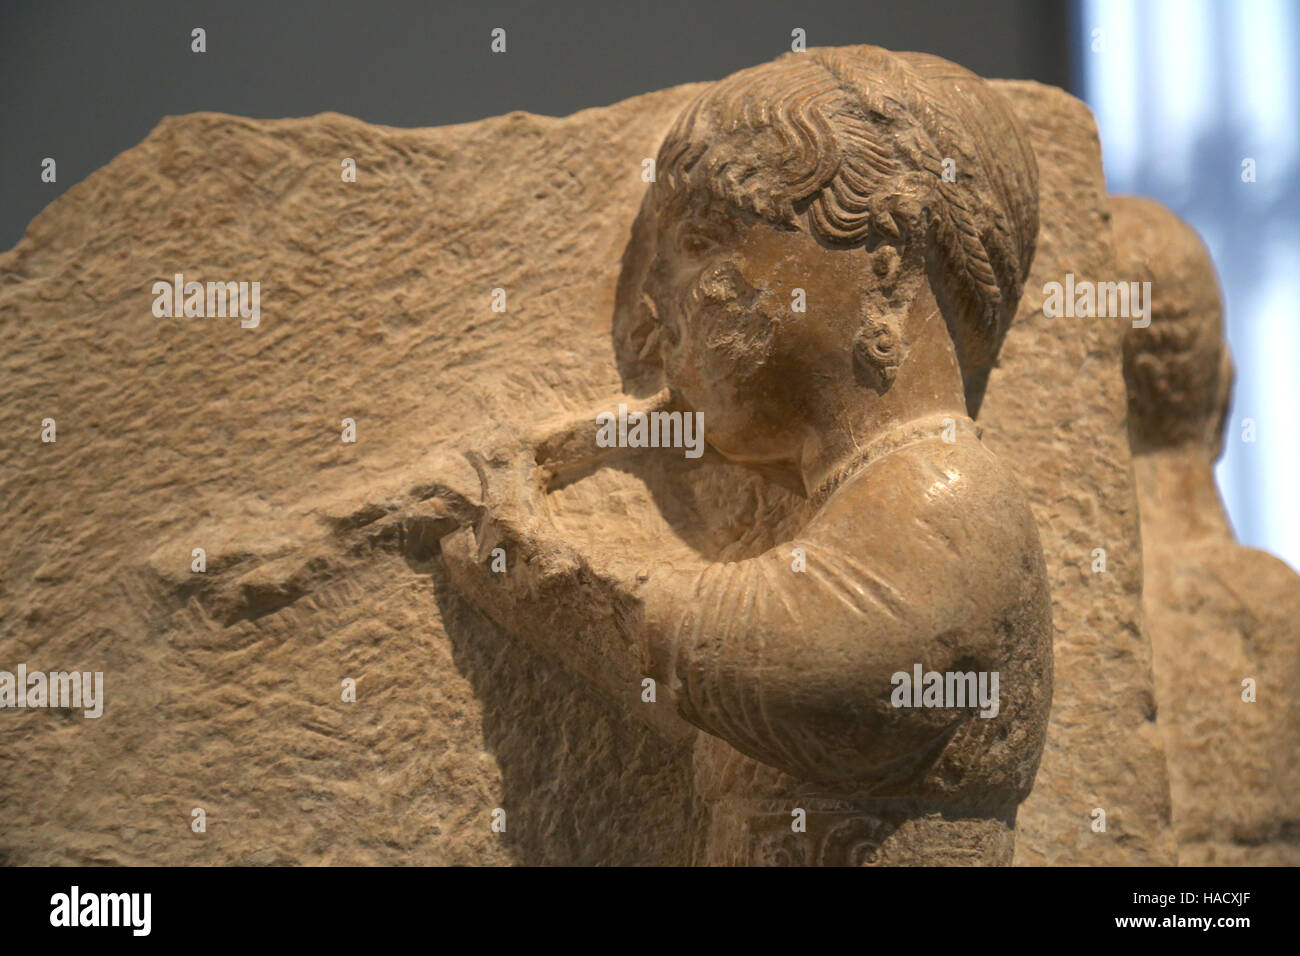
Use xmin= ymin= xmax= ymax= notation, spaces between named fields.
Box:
xmin=445 ymin=429 xmax=1050 ymax=788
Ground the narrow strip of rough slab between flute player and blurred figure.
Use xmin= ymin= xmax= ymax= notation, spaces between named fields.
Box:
xmin=979 ymin=82 xmax=1174 ymax=865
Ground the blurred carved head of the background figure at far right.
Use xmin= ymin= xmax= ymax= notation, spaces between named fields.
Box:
xmin=1112 ymin=196 xmax=1234 ymax=460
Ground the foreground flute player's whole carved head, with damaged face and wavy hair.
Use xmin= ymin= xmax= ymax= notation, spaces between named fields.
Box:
xmin=615 ymin=47 xmax=1037 ymax=489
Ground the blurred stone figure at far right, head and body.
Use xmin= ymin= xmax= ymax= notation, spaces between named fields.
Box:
xmin=1113 ymin=198 xmax=1300 ymax=866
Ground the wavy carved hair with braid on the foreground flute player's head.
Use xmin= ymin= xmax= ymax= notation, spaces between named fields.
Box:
xmin=657 ymin=46 xmax=1039 ymax=403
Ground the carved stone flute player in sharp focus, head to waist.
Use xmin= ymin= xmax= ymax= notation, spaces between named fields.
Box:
xmin=431 ymin=47 xmax=1052 ymax=862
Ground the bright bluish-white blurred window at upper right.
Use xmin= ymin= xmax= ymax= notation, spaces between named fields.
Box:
xmin=1075 ymin=0 xmax=1300 ymax=570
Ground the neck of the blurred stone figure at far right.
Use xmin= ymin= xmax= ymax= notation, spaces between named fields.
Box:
xmin=1134 ymin=444 xmax=1234 ymax=542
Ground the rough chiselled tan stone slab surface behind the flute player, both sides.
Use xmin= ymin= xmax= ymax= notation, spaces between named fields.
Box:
xmin=0 ymin=76 xmax=1171 ymax=864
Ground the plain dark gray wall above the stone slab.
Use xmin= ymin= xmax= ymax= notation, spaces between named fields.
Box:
xmin=0 ymin=0 xmax=1070 ymax=250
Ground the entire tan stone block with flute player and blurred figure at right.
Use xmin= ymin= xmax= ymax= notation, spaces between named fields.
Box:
xmin=0 ymin=39 xmax=1279 ymax=865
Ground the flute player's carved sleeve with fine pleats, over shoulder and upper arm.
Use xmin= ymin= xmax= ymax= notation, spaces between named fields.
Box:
xmin=647 ymin=419 xmax=1050 ymax=799
